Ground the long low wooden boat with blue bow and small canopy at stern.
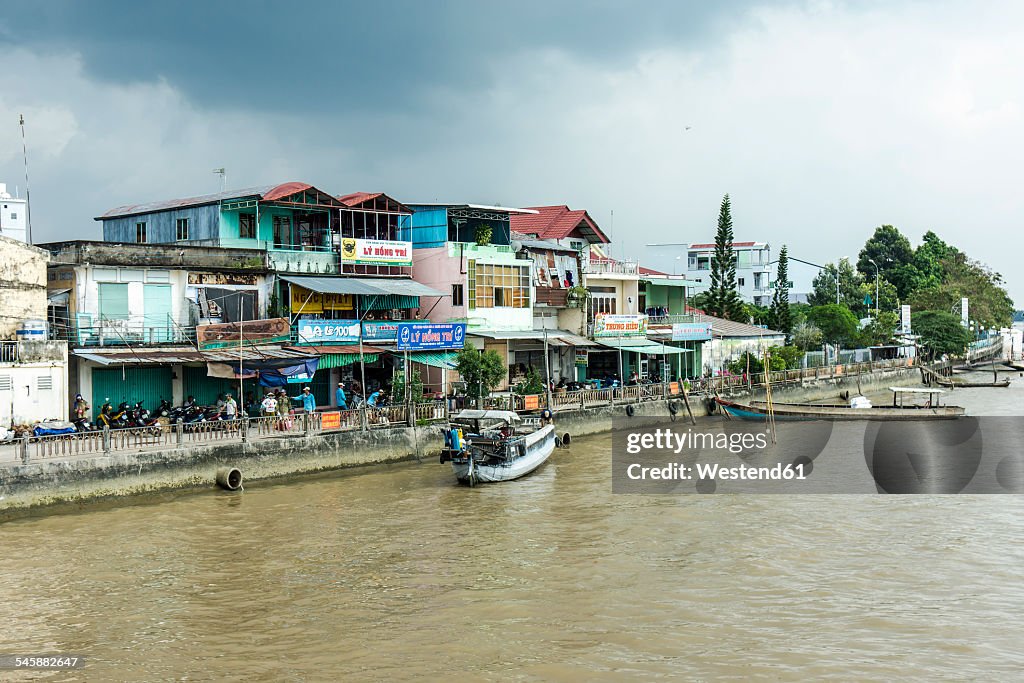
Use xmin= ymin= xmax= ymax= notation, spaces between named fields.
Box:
xmin=715 ymin=387 xmax=965 ymax=421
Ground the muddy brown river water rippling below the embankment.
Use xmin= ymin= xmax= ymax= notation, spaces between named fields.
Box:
xmin=0 ymin=376 xmax=1024 ymax=681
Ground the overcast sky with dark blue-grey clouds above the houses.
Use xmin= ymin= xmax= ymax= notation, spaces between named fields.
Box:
xmin=0 ymin=0 xmax=1024 ymax=307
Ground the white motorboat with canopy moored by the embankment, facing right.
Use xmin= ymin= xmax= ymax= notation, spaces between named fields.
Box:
xmin=440 ymin=411 xmax=555 ymax=486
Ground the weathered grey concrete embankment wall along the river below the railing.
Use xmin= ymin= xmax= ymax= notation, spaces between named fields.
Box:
xmin=0 ymin=368 xmax=919 ymax=520
